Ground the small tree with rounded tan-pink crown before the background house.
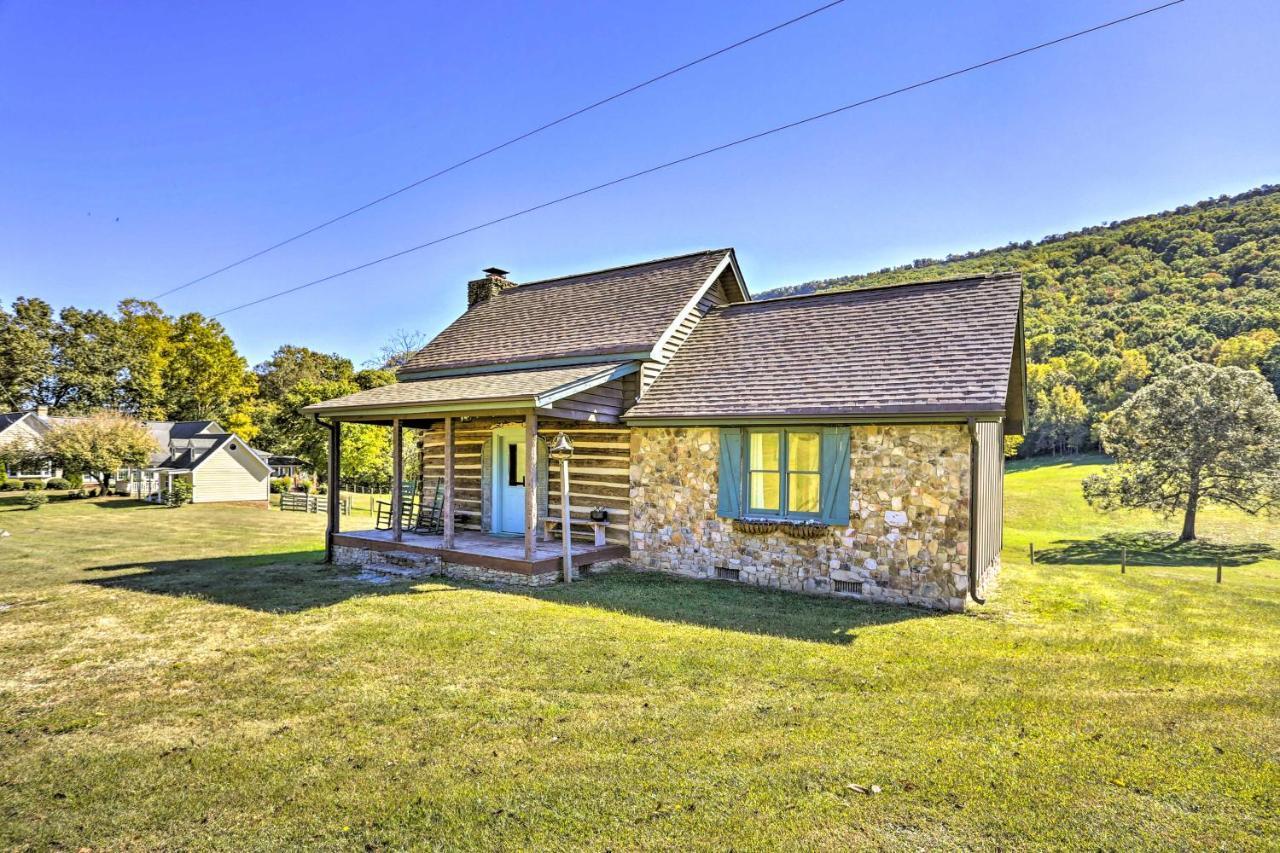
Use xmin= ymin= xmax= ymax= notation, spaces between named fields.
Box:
xmin=41 ymin=411 xmax=160 ymax=491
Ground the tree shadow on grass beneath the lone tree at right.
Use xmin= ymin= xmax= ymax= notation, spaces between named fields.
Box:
xmin=1036 ymin=533 xmax=1280 ymax=566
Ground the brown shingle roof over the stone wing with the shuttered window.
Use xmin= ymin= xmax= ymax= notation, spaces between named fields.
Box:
xmin=625 ymin=275 xmax=1021 ymax=420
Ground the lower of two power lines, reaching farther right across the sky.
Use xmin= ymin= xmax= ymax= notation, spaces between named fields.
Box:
xmin=212 ymin=0 xmax=1187 ymax=318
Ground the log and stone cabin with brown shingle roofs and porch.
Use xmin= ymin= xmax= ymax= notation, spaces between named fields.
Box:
xmin=303 ymin=248 xmax=1025 ymax=610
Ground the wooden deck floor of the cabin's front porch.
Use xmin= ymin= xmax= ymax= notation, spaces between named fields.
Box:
xmin=333 ymin=530 xmax=630 ymax=575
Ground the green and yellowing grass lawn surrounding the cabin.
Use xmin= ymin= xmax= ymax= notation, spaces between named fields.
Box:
xmin=0 ymin=460 xmax=1280 ymax=849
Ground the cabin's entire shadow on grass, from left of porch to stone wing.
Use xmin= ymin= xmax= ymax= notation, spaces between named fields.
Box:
xmin=79 ymin=549 xmax=946 ymax=644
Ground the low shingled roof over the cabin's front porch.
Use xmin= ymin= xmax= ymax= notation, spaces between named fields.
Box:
xmin=302 ymin=362 xmax=637 ymax=423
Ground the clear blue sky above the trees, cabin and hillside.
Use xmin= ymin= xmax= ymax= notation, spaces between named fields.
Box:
xmin=0 ymin=0 xmax=1280 ymax=362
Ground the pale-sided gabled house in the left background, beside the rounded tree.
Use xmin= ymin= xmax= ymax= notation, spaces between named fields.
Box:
xmin=116 ymin=420 xmax=271 ymax=503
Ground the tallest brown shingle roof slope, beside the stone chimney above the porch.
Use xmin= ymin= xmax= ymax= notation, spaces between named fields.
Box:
xmin=399 ymin=248 xmax=732 ymax=374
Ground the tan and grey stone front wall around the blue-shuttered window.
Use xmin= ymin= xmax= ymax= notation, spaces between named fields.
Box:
xmin=631 ymin=424 xmax=969 ymax=610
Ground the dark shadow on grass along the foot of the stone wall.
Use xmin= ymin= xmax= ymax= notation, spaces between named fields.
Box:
xmin=511 ymin=570 xmax=952 ymax=646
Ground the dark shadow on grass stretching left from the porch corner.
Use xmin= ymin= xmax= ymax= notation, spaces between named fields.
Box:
xmin=79 ymin=549 xmax=424 ymax=613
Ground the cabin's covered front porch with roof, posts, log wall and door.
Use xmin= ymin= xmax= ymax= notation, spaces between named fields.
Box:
xmin=303 ymin=362 xmax=635 ymax=583
